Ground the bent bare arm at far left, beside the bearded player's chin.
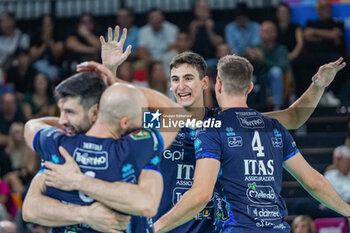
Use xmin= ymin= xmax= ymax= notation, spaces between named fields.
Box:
xmin=24 ymin=117 xmax=63 ymax=149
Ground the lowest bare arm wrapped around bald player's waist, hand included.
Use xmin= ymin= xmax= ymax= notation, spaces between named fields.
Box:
xmin=22 ymin=173 xmax=130 ymax=232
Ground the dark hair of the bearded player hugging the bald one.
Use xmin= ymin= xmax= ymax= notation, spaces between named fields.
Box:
xmin=55 ymin=72 xmax=107 ymax=110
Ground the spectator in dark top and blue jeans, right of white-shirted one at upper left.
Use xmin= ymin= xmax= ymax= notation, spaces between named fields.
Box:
xmin=30 ymin=15 xmax=64 ymax=80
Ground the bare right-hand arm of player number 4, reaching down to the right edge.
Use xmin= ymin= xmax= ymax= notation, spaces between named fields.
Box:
xmin=284 ymin=153 xmax=350 ymax=217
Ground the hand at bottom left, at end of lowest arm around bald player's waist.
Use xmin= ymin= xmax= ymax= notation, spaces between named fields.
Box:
xmin=84 ymin=202 xmax=130 ymax=233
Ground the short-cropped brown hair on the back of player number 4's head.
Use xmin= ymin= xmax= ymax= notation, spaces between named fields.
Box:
xmin=218 ymin=54 xmax=253 ymax=95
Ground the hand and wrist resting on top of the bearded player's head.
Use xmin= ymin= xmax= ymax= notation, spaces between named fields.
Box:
xmin=77 ymin=61 xmax=121 ymax=86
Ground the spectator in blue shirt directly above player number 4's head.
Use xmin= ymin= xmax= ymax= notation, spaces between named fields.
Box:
xmin=225 ymin=2 xmax=260 ymax=56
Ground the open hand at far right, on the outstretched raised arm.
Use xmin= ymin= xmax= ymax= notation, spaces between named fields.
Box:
xmin=312 ymin=57 xmax=346 ymax=87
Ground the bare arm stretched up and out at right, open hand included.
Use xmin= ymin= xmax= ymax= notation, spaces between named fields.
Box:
xmin=263 ymin=58 xmax=346 ymax=129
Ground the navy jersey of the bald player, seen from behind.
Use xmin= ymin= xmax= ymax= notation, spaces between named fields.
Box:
xmin=34 ymin=128 xmax=161 ymax=233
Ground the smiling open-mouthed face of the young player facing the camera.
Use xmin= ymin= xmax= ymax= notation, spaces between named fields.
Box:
xmin=170 ymin=63 xmax=208 ymax=107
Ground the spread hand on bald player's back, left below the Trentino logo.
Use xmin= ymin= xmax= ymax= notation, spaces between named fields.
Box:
xmin=44 ymin=146 xmax=84 ymax=191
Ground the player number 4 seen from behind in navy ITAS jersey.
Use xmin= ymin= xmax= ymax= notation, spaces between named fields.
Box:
xmin=154 ymin=55 xmax=350 ymax=233
